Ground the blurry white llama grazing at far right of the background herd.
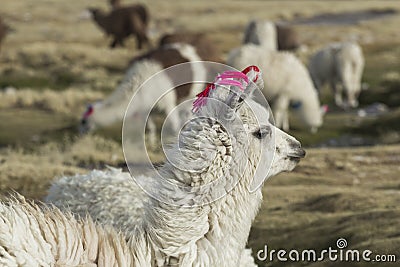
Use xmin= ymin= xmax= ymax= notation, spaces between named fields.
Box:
xmin=309 ymin=43 xmax=364 ymax=108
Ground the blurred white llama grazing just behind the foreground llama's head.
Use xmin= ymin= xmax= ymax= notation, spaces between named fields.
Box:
xmin=227 ymin=44 xmax=327 ymax=132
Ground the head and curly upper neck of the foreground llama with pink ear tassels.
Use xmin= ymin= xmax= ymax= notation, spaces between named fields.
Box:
xmin=158 ymin=66 xmax=305 ymax=204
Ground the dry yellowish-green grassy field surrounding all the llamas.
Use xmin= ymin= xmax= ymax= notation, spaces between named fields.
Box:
xmin=0 ymin=0 xmax=400 ymax=266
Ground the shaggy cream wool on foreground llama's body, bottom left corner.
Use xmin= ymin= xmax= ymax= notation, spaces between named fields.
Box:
xmin=0 ymin=195 xmax=141 ymax=267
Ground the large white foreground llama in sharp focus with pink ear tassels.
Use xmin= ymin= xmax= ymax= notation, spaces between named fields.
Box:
xmin=0 ymin=67 xmax=305 ymax=266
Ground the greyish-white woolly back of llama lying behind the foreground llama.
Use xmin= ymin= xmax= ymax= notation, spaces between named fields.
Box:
xmin=45 ymin=168 xmax=147 ymax=232
